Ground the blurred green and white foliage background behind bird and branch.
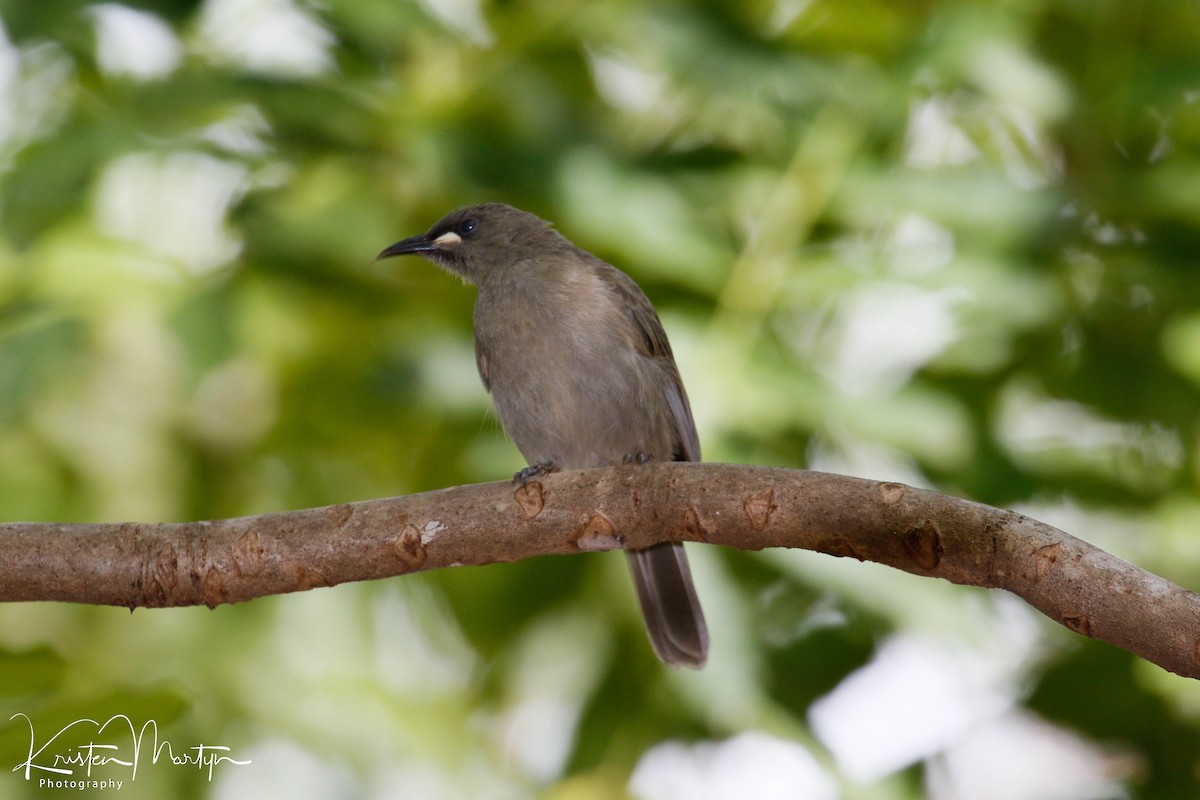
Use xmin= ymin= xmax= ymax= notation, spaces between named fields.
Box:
xmin=0 ymin=0 xmax=1200 ymax=800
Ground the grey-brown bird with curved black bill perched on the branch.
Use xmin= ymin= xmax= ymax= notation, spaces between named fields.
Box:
xmin=376 ymin=203 xmax=708 ymax=669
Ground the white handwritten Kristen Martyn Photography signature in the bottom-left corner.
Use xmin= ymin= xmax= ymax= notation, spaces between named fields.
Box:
xmin=8 ymin=712 xmax=250 ymax=790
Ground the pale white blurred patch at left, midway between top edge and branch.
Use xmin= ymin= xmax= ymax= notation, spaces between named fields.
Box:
xmin=96 ymin=152 xmax=247 ymax=275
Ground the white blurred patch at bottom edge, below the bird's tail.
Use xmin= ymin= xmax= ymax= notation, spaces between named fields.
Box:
xmin=629 ymin=732 xmax=838 ymax=800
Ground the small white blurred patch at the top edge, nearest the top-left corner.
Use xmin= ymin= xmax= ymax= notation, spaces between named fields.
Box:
xmin=90 ymin=2 xmax=184 ymax=80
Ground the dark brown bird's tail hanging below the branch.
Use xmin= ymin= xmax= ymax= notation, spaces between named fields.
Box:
xmin=626 ymin=542 xmax=708 ymax=669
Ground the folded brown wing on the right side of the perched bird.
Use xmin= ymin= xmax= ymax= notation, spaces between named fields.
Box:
xmin=592 ymin=259 xmax=700 ymax=461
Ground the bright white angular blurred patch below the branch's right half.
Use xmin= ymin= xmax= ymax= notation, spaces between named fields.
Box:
xmin=809 ymin=634 xmax=1014 ymax=783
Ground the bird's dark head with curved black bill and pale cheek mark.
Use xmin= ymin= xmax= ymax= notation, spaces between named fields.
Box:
xmin=376 ymin=203 xmax=561 ymax=284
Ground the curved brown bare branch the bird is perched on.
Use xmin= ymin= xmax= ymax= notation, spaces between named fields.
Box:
xmin=0 ymin=463 xmax=1200 ymax=678
